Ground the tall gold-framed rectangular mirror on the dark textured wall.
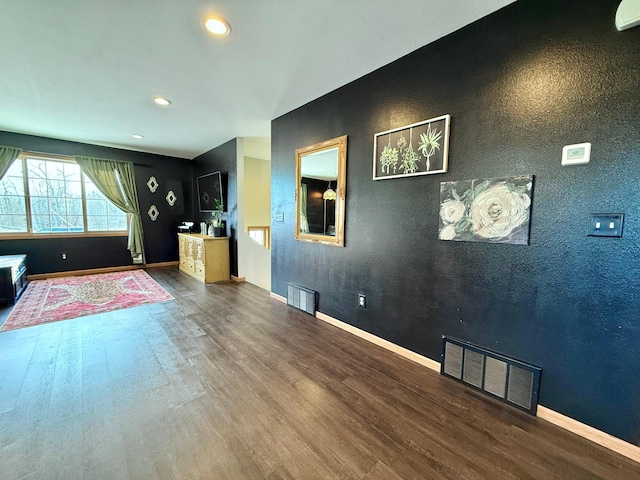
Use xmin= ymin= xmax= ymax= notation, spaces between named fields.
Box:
xmin=295 ymin=135 xmax=347 ymax=247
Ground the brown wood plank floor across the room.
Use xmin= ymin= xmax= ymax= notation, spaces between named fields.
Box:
xmin=0 ymin=267 xmax=640 ymax=480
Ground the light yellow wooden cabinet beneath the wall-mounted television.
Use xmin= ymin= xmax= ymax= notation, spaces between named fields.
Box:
xmin=178 ymin=233 xmax=229 ymax=283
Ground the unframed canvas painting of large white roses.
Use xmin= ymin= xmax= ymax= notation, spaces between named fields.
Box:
xmin=439 ymin=175 xmax=533 ymax=245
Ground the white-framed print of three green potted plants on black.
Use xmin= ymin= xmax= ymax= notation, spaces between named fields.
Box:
xmin=373 ymin=115 xmax=451 ymax=180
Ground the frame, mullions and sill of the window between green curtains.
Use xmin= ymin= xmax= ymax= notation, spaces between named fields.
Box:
xmin=0 ymin=151 xmax=131 ymax=240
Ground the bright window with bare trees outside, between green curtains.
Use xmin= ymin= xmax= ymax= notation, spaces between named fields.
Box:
xmin=0 ymin=154 xmax=127 ymax=234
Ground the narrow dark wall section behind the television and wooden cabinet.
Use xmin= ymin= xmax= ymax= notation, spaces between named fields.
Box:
xmin=193 ymin=138 xmax=238 ymax=276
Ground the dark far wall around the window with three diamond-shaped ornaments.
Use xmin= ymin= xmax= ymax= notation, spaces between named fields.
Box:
xmin=0 ymin=131 xmax=193 ymax=274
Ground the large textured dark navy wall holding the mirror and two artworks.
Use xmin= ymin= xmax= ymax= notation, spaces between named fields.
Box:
xmin=272 ymin=0 xmax=640 ymax=445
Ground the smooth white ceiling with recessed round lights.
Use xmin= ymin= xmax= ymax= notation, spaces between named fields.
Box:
xmin=0 ymin=0 xmax=513 ymax=159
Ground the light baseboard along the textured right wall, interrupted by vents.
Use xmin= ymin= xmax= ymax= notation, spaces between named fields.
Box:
xmin=270 ymin=292 xmax=640 ymax=463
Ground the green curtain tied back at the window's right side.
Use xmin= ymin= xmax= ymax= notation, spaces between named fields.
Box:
xmin=74 ymin=157 xmax=145 ymax=263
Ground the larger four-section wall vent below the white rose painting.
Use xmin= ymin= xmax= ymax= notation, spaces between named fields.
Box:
xmin=440 ymin=336 xmax=542 ymax=415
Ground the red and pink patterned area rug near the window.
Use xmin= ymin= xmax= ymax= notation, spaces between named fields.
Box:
xmin=0 ymin=270 xmax=173 ymax=331
